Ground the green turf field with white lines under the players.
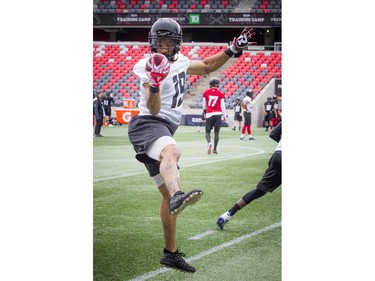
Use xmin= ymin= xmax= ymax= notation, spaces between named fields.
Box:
xmin=93 ymin=125 xmax=281 ymax=281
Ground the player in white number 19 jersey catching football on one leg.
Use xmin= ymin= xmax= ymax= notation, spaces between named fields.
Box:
xmin=128 ymin=18 xmax=255 ymax=272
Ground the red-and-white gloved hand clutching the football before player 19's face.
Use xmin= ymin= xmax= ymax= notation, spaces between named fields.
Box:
xmin=145 ymin=53 xmax=170 ymax=88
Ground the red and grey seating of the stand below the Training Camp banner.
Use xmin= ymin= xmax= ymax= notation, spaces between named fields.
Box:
xmin=93 ymin=42 xmax=282 ymax=109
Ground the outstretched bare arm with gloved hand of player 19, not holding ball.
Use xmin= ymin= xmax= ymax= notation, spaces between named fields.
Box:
xmin=187 ymin=27 xmax=255 ymax=75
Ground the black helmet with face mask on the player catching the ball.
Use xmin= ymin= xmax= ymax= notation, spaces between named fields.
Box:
xmin=148 ymin=18 xmax=182 ymax=62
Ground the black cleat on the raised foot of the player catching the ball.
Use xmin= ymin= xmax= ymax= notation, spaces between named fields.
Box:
xmin=169 ymin=189 xmax=203 ymax=216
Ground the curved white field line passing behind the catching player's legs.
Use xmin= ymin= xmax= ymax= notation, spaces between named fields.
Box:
xmin=93 ymin=147 xmax=266 ymax=182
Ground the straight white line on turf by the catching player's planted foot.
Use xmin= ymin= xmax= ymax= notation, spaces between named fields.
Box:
xmin=130 ymin=222 xmax=281 ymax=281
